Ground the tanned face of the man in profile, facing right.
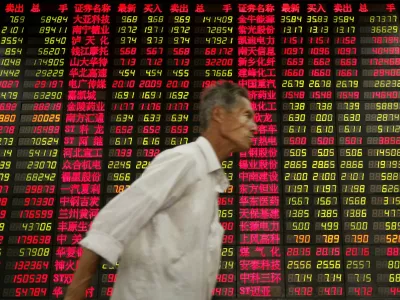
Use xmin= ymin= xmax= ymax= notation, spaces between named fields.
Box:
xmin=221 ymin=97 xmax=257 ymax=152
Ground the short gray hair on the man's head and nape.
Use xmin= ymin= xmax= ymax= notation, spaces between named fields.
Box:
xmin=200 ymin=81 xmax=249 ymax=132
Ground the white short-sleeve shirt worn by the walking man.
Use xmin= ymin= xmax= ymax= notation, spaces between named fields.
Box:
xmin=80 ymin=137 xmax=229 ymax=300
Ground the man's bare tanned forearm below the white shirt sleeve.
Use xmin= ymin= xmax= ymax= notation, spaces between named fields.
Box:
xmin=64 ymin=248 xmax=100 ymax=300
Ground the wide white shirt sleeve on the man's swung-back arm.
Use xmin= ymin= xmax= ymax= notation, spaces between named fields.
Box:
xmin=80 ymin=150 xmax=196 ymax=264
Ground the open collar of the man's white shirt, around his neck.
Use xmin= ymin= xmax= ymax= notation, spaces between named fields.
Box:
xmin=196 ymin=136 xmax=229 ymax=193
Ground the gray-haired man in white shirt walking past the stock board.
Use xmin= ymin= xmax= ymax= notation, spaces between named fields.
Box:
xmin=65 ymin=82 xmax=257 ymax=300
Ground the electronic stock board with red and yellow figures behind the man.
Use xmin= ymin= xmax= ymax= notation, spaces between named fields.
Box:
xmin=0 ymin=1 xmax=400 ymax=300
